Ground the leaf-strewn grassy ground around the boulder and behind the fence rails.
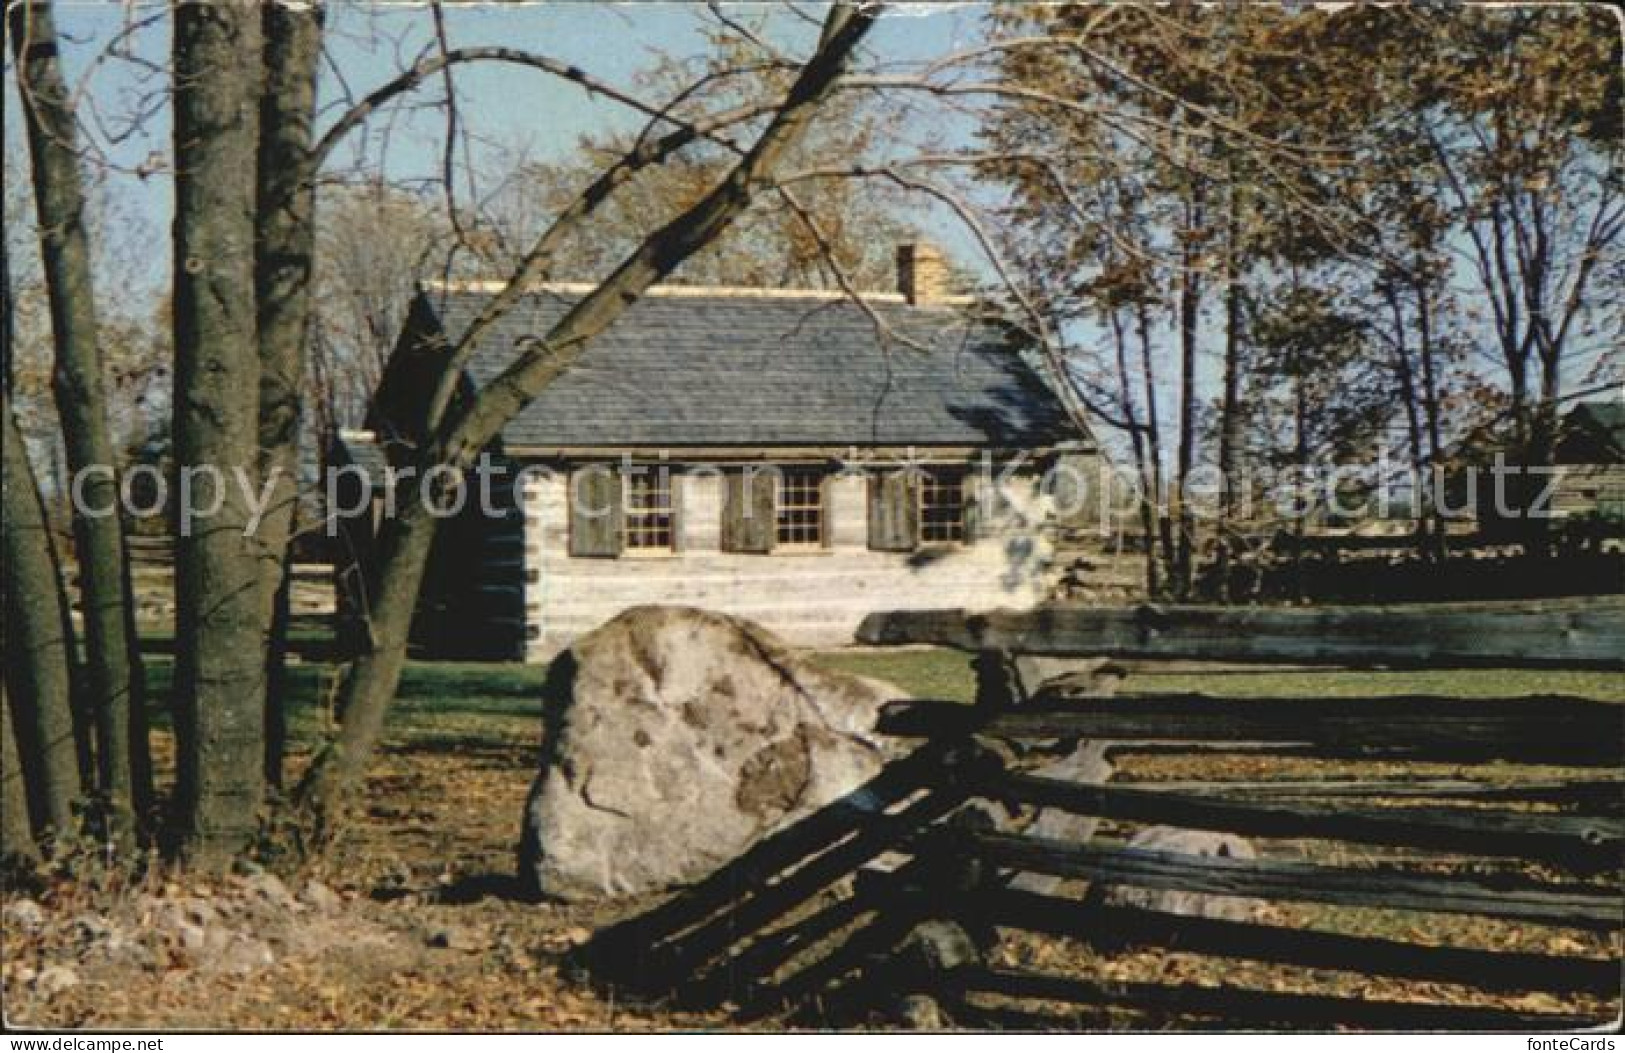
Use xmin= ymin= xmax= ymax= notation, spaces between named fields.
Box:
xmin=25 ymin=640 xmax=1625 ymax=1030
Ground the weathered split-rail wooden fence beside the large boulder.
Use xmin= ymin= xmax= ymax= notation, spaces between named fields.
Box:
xmin=582 ymin=601 xmax=1625 ymax=1030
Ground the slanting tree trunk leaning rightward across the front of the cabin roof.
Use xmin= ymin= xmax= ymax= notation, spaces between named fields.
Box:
xmin=299 ymin=5 xmax=879 ymax=843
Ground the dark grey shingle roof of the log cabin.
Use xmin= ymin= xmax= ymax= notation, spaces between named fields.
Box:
xmin=424 ymin=289 xmax=1084 ymax=449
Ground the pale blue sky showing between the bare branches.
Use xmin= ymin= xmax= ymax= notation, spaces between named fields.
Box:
xmin=5 ymin=0 xmax=982 ymax=289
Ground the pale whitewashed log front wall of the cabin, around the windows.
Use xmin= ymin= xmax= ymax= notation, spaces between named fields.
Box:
xmin=522 ymin=473 xmax=1055 ymax=661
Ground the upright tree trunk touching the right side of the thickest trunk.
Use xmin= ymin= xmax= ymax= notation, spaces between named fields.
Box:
xmin=254 ymin=3 xmax=323 ymax=787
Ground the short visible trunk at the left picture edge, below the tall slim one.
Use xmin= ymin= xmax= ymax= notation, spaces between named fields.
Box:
xmin=0 ymin=397 xmax=80 ymax=839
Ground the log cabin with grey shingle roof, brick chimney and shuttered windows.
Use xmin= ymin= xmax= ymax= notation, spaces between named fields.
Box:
xmin=330 ymin=245 xmax=1099 ymax=661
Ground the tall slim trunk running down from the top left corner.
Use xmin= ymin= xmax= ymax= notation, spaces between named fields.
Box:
xmin=10 ymin=2 xmax=153 ymax=842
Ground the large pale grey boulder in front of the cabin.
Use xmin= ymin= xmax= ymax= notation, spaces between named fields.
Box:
xmin=518 ymin=606 xmax=902 ymax=900
